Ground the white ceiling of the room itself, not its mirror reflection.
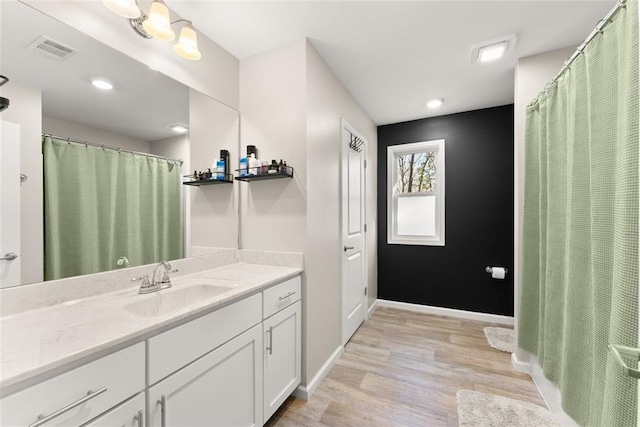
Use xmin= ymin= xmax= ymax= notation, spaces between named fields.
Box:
xmin=169 ymin=0 xmax=615 ymax=125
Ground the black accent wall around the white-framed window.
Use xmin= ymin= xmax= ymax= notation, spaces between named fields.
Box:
xmin=378 ymin=105 xmax=514 ymax=316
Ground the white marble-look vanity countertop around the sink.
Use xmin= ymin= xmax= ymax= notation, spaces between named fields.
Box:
xmin=0 ymin=262 xmax=302 ymax=388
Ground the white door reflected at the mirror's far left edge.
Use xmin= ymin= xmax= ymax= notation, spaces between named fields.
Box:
xmin=0 ymin=120 xmax=21 ymax=288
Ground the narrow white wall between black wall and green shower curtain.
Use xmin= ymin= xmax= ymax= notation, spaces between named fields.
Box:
xmin=513 ymin=47 xmax=575 ymax=363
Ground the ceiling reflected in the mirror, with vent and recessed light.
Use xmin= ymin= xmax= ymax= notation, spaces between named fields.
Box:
xmin=0 ymin=2 xmax=189 ymax=141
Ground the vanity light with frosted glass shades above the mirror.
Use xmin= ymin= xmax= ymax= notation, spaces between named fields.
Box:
xmin=102 ymin=0 xmax=202 ymax=61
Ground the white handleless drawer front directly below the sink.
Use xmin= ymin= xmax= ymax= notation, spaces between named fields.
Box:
xmin=148 ymin=294 xmax=262 ymax=385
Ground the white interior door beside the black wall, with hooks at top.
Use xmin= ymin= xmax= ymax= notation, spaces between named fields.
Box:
xmin=341 ymin=120 xmax=367 ymax=344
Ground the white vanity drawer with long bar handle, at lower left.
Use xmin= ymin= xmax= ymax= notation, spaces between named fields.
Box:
xmin=0 ymin=343 xmax=145 ymax=427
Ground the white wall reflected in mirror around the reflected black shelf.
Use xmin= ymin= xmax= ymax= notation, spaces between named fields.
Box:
xmin=191 ymin=90 xmax=240 ymax=252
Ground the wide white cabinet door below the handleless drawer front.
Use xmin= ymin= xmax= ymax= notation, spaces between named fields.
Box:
xmin=148 ymin=325 xmax=262 ymax=427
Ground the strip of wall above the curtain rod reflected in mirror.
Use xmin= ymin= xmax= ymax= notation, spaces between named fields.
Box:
xmin=42 ymin=116 xmax=150 ymax=153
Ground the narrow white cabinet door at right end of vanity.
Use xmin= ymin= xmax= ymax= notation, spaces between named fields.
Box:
xmin=263 ymin=301 xmax=302 ymax=422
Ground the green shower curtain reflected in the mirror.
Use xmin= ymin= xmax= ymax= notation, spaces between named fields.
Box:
xmin=42 ymin=136 xmax=183 ymax=280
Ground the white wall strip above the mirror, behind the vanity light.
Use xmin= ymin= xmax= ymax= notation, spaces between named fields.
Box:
xmin=21 ymin=0 xmax=239 ymax=109
